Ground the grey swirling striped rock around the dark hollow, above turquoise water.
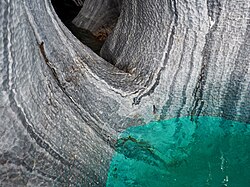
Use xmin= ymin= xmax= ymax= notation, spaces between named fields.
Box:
xmin=0 ymin=0 xmax=250 ymax=186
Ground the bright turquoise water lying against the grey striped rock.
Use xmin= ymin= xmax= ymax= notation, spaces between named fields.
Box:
xmin=107 ymin=116 xmax=250 ymax=187
